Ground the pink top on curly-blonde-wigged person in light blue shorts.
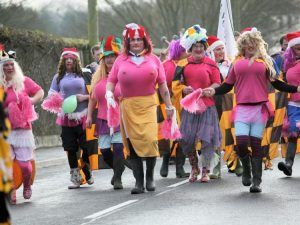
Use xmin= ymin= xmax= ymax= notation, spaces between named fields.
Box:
xmin=225 ymin=58 xmax=269 ymax=104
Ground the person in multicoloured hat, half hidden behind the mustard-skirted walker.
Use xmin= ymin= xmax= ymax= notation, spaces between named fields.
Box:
xmin=86 ymin=35 xmax=129 ymax=189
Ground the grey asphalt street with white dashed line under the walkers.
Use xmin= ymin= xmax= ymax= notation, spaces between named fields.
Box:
xmin=10 ymin=157 xmax=300 ymax=225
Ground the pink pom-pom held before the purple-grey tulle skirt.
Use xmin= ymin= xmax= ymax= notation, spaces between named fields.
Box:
xmin=180 ymin=88 xmax=207 ymax=113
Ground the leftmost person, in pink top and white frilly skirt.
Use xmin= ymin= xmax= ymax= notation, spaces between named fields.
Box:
xmin=0 ymin=44 xmax=44 ymax=204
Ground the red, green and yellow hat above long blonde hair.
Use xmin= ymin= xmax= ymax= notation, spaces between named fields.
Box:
xmin=100 ymin=35 xmax=122 ymax=59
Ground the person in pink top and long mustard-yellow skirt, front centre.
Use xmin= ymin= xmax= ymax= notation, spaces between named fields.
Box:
xmin=106 ymin=23 xmax=174 ymax=194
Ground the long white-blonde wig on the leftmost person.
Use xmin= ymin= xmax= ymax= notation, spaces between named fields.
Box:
xmin=0 ymin=60 xmax=25 ymax=93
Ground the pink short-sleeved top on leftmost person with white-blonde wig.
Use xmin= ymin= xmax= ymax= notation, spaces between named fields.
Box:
xmin=4 ymin=77 xmax=42 ymax=129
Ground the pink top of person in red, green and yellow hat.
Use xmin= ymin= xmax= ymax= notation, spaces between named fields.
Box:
xmin=92 ymin=78 xmax=121 ymax=120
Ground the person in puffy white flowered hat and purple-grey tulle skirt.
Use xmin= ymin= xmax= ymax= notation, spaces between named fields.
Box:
xmin=174 ymin=25 xmax=221 ymax=182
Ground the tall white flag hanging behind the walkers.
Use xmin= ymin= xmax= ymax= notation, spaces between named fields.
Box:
xmin=217 ymin=0 xmax=237 ymax=60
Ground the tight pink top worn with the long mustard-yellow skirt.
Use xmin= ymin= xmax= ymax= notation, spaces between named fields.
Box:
xmin=108 ymin=54 xmax=166 ymax=97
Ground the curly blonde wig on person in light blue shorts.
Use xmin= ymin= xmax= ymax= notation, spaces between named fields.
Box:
xmin=237 ymin=31 xmax=276 ymax=78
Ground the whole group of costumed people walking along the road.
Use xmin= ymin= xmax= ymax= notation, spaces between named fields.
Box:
xmin=0 ymin=23 xmax=300 ymax=222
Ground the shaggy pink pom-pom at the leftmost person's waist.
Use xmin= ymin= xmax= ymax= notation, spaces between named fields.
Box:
xmin=8 ymin=95 xmax=38 ymax=128
